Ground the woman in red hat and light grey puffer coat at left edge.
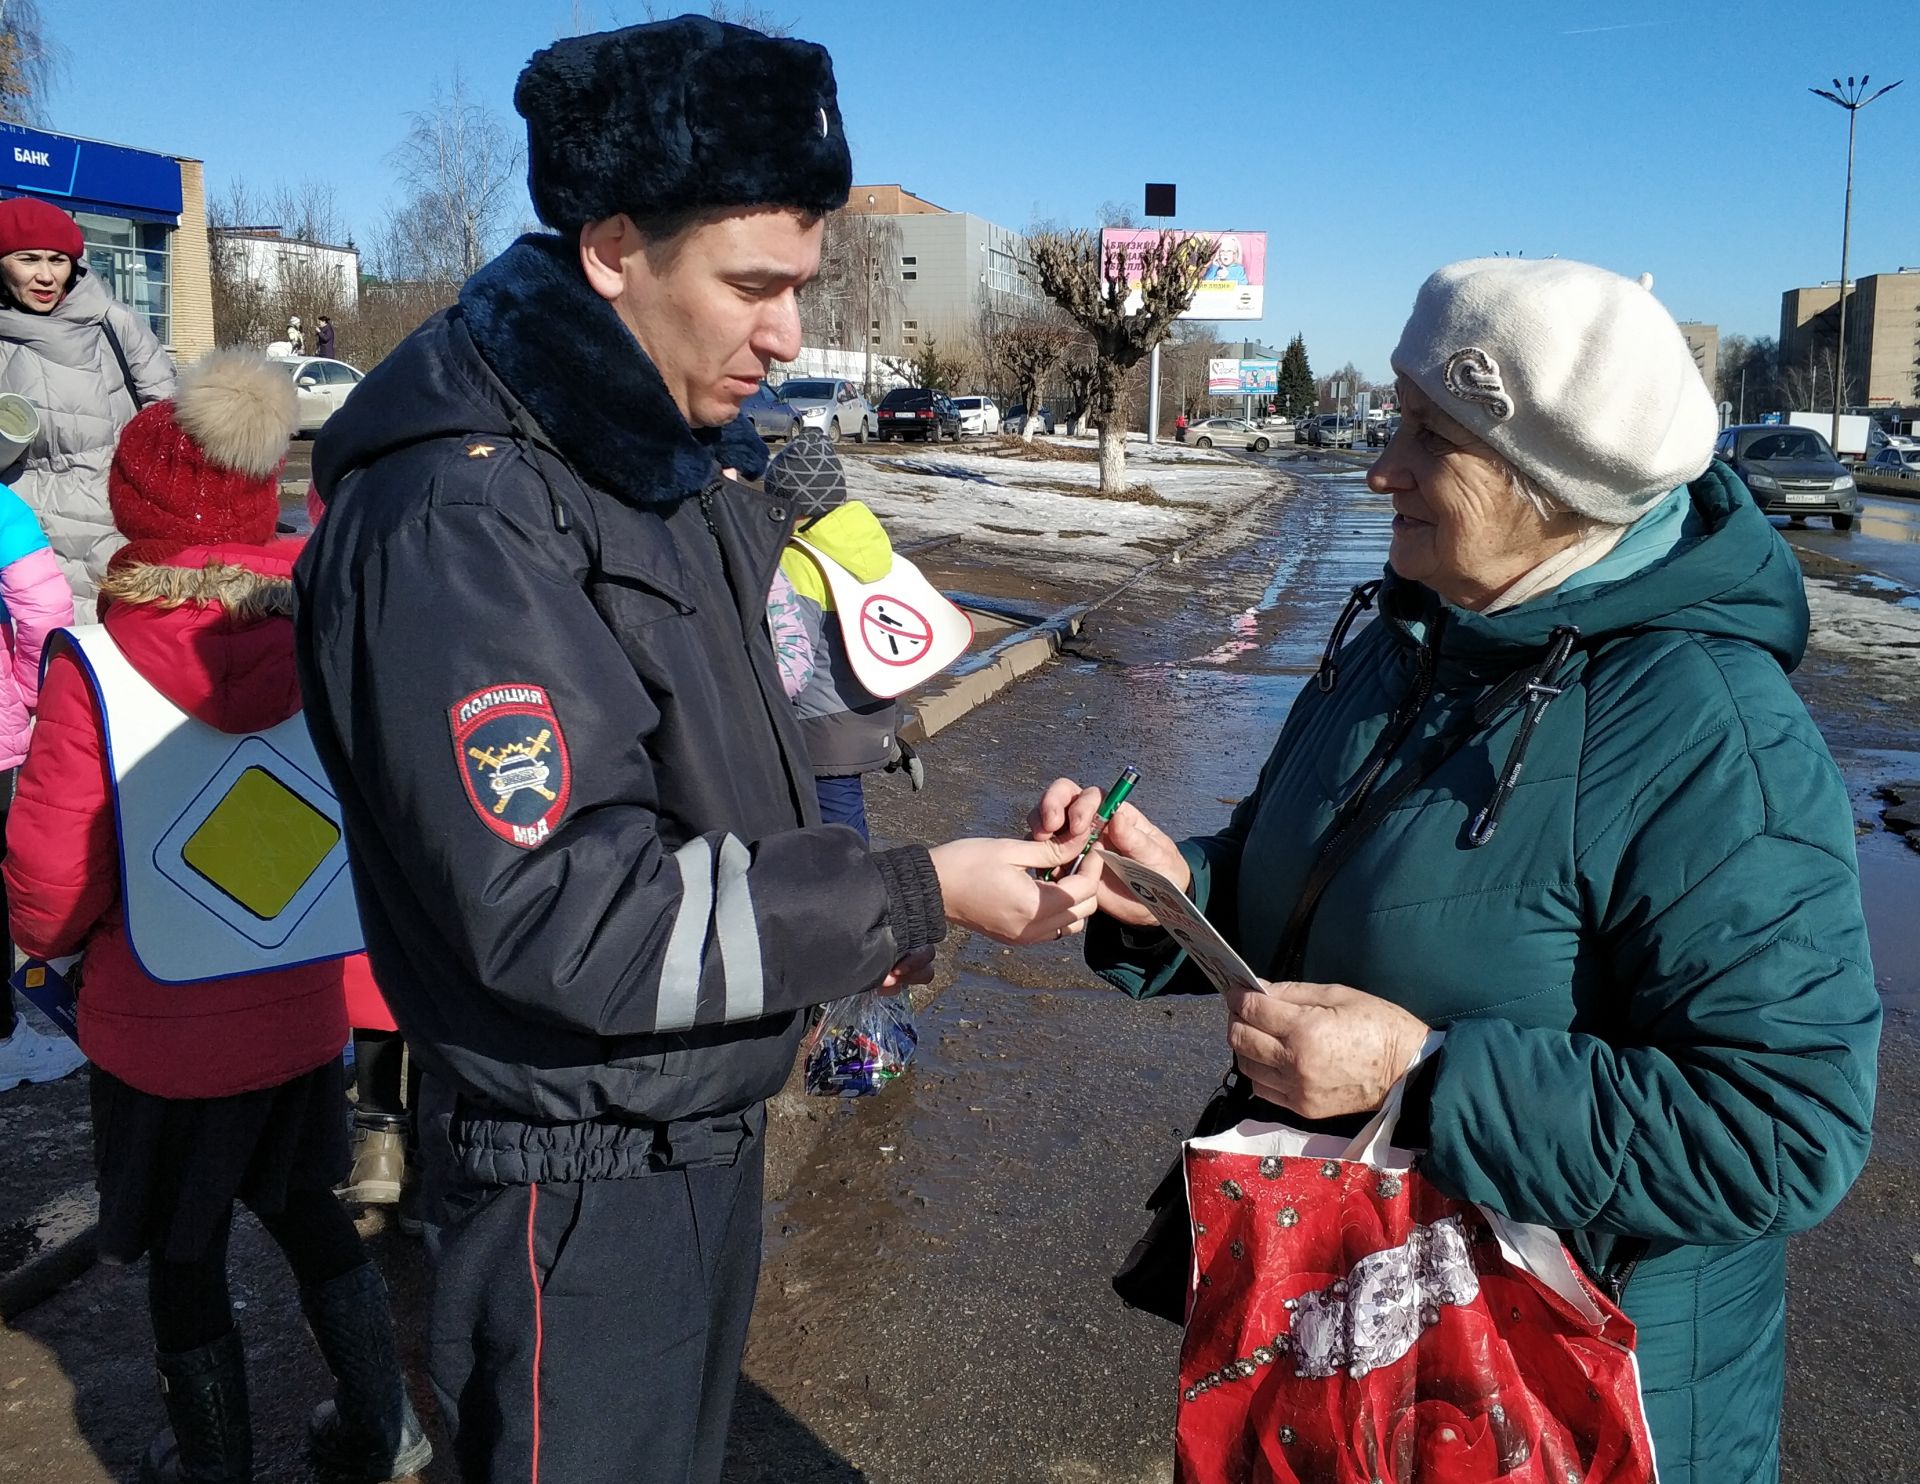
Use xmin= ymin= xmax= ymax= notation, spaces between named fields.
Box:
xmin=0 ymin=196 xmax=173 ymax=622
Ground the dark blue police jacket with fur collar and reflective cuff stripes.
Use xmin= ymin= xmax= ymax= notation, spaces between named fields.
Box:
xmin=296 ymin=238 xmax=945 ymax=1183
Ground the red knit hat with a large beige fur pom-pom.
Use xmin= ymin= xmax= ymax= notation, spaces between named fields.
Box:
xmin=108 ymin=351 xmax=300 ymax=568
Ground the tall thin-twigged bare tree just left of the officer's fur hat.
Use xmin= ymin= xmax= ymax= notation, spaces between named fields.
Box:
xmin=376 ymin=71 xmax=522 ymax=284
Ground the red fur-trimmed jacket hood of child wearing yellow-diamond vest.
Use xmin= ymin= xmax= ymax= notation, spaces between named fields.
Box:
xmin=100 ymin=541 xmax=303 ymax=733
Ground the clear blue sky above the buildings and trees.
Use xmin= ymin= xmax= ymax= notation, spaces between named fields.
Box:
xmin=40 ymin=0 xmax=1920 ymax=376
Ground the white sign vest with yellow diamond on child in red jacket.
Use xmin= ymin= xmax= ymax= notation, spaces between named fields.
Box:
xmin=56 ymin=626 xmax=363 ymax=985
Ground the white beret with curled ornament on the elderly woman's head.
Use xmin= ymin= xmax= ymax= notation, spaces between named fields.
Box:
xmin=1394 ymin=257 xmax=1720 ymax=526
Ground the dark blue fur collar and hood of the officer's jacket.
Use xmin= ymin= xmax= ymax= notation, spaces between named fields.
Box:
xmin=313 ymin=234 xmax=766 ymax=505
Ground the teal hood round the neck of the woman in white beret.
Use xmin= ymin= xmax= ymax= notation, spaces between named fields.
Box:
xmin=1380 ymin=463 xmax=1807 ymax=672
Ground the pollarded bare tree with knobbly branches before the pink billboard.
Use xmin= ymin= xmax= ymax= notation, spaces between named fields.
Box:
xmin=1031 ymin=230 xmax=1215 ymax=493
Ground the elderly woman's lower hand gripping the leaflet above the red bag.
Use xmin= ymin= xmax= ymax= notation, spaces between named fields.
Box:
xmin=1225 ymin=981 xmax=1430 ymax=1117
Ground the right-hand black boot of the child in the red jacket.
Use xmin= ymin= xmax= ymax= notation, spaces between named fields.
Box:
xmin=300 ymin=1263 xmax=434 ymax=1484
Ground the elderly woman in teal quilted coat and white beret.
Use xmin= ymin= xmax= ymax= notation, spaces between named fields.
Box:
xmin=1033 ymin=259 xmax=1880 ymax=1484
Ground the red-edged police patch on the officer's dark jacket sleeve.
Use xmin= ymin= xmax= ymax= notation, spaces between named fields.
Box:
xmin=447 ymin=683 xmax=574 ymax=850
